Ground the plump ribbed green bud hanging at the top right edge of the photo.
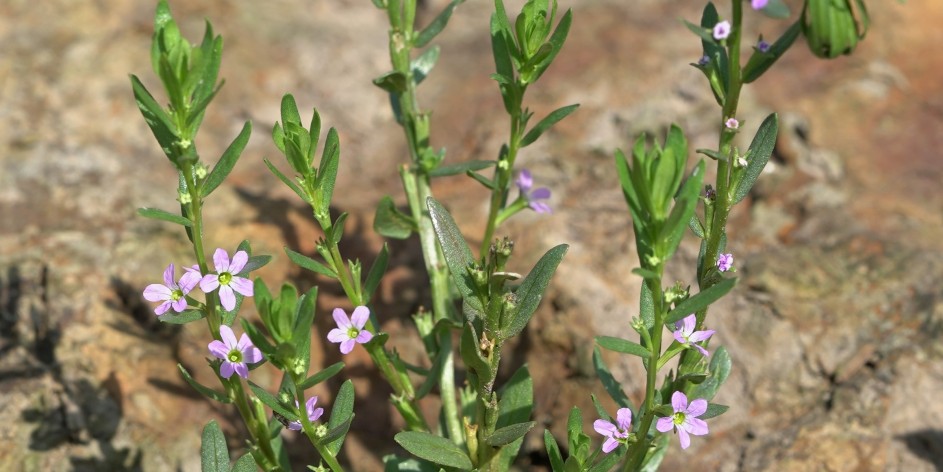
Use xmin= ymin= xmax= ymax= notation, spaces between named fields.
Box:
xmin=802 ymin=0 xmax=870 ymax=59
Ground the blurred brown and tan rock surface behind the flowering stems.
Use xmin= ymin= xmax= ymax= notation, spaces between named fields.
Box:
xmin=0 ymin=0 xmax=943 ymax=471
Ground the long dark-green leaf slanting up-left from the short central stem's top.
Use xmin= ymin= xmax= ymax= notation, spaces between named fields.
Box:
xmin=426 ymin=197 xmax=485 ymax=313
